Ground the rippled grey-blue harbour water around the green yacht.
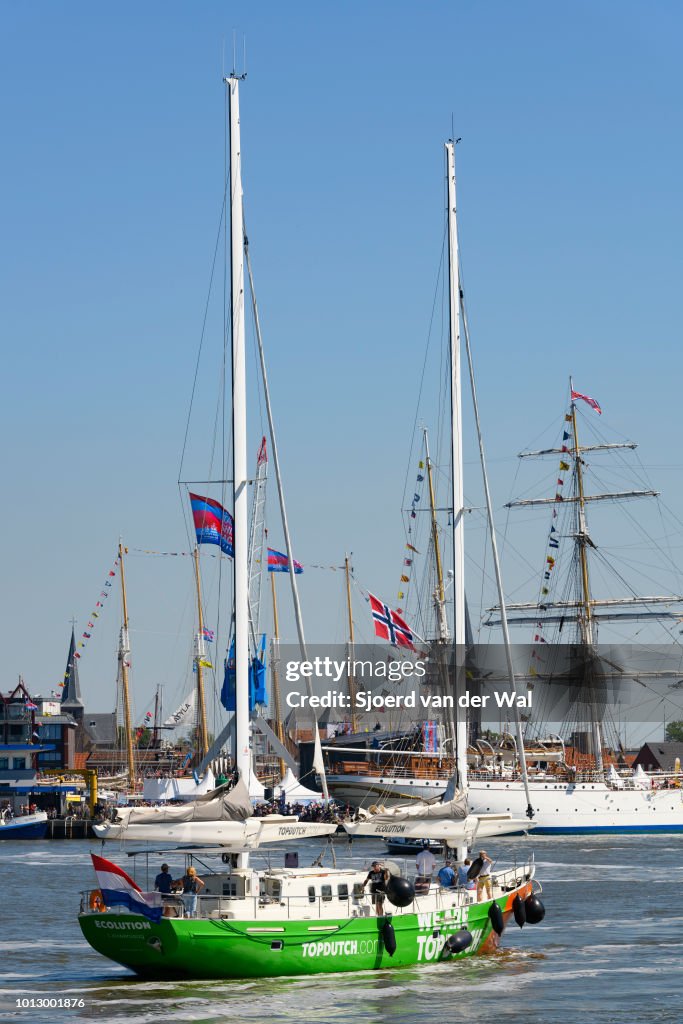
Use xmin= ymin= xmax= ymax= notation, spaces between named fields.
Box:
xmin=0 ymin=836 xmax=683 ymax=1024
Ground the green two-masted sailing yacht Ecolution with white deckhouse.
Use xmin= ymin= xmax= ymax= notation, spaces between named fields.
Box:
xmin=79 ymin=74 xmax=545 ymax=979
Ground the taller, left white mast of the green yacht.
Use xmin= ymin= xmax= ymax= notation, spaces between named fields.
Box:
xmin=225 ymin=73 xmax=251 ymax=785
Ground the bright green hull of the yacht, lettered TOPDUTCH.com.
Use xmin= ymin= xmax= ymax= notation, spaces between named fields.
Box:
xmin=79 ymin=885 xmax=530 ymax=978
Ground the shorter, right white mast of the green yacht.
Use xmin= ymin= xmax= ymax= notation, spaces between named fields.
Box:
xmin=445 ymin=141 xmax=467 ymax=790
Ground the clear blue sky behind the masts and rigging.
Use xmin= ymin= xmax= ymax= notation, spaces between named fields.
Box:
xmin=0 ymin=0 xmax=683 ymax=737
